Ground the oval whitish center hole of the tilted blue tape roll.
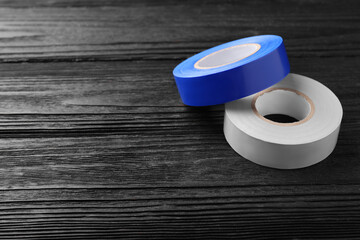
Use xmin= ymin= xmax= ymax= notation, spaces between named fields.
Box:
xmin=194 ymin=43 xmax=261 ymax=69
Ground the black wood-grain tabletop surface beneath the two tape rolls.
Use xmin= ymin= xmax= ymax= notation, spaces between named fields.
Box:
xmin=0 ymin=0 xmax=360 ymax=239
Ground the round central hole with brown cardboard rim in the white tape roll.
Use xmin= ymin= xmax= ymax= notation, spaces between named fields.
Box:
xmin=253 ymin=88 xmax=314 ymax=125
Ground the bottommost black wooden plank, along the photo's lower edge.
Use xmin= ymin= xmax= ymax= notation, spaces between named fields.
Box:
xmin=0 ymin=185 xmax=360 ymax=239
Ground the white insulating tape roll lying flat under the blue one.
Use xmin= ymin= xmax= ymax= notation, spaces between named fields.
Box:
xmin=224 ymin=73 xmax=343 ymax=169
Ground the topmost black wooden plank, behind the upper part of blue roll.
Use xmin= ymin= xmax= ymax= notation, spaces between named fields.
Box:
xmin=0 ymin=0 xmax=360 ymax=62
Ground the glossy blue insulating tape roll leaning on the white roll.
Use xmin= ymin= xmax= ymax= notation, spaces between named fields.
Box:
xmin=173 ymin=35 xmax=290 ymax=106
